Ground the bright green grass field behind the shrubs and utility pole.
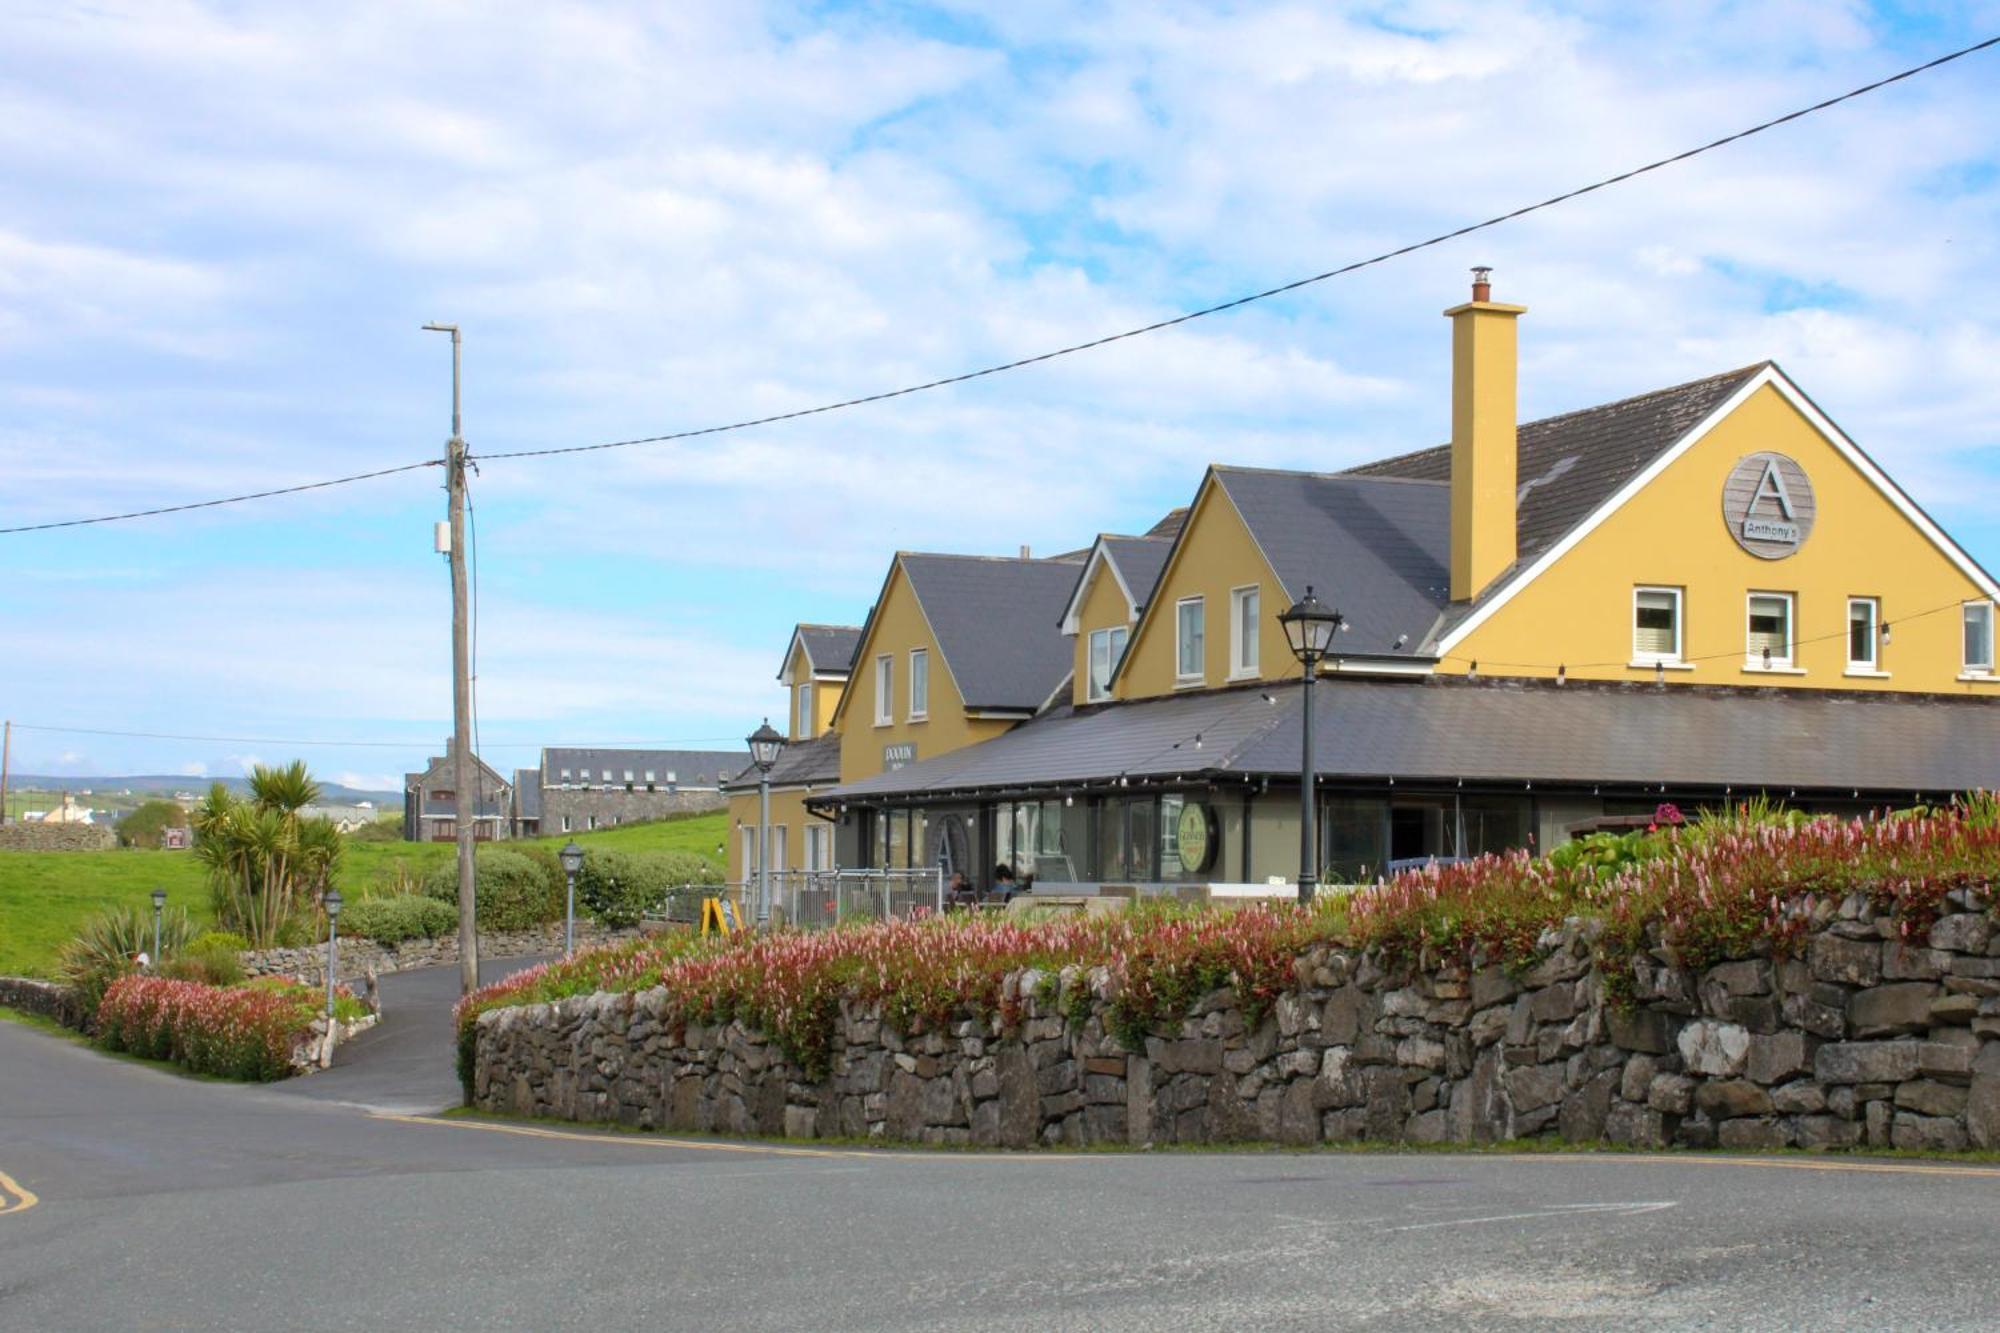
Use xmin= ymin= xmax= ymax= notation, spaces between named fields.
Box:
xmin=0 ymin=811 xmax=728 ymax=977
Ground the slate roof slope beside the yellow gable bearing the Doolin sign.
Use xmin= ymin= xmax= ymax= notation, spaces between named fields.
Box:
xmin=898 ymin=552 xmax=1078 ymax=713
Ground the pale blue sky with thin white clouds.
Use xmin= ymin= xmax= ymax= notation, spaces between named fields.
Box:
xmin=0 ymin=0 xmax=2000 ymax=785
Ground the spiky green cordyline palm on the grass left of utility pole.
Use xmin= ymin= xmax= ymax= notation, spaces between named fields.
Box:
xmin=192 ymin=761 xmax=340 ymax=949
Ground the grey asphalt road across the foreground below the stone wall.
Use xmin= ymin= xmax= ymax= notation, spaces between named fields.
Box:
xmin=0 ymin=972 xmax=2000 ymax=1331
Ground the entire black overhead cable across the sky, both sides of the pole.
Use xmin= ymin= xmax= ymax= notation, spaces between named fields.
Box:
xmin=0 ymin=36 xmax=2000 ymax=536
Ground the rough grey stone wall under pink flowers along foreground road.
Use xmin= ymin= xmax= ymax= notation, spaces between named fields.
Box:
xmin=472 ymin=880 xmax=2000 ymax=1149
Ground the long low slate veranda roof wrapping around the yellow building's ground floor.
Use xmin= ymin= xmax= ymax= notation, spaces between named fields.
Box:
xmin=818 ymin=679 xmax=2000 ymax=803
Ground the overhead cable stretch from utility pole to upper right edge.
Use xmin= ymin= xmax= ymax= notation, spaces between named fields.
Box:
xmin=478 ymin=36 xmax=2000 ymax=458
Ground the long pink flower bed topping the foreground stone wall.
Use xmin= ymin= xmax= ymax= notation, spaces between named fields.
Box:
xmin=456 ymin=799 xmax=2000 ymax=1087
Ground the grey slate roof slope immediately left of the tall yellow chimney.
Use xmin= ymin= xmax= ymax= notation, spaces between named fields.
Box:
xmin=1212 ymin=466 xmax=1452 ymax=656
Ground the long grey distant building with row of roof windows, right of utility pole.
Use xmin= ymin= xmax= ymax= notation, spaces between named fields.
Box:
xmin=536 ymin=749 xmax=744 ymax=835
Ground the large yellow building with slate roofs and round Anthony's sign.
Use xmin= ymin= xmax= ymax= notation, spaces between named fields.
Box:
xmin=814 ymin=272 xmax=2000 ymax=891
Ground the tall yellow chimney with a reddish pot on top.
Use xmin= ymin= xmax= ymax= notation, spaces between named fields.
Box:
xmin=1444 ymin=268 xmax=1528 ymax=602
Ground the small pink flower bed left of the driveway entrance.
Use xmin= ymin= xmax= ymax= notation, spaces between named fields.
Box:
xmin=98 ymin=975 xmax=364 ymax=1083
